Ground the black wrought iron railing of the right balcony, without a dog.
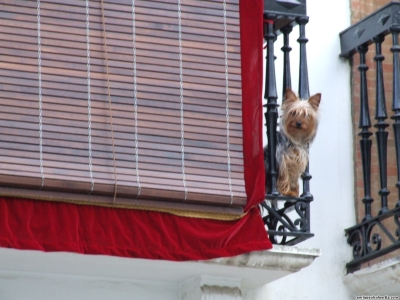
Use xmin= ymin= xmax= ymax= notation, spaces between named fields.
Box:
xmin=340 ymin=2 xmax=400 ymax=272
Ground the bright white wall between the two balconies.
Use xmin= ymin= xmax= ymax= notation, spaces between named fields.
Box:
xmin=250 ymin=0 xmax=355 ymax=300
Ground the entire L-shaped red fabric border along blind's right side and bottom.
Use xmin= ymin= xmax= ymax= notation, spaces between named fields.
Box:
xmin=0 ymin=0 xmax=272 ymax=261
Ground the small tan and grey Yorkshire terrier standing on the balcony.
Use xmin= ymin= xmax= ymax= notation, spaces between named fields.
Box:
xmin=264 ymin=88 xmax=321 ymax=197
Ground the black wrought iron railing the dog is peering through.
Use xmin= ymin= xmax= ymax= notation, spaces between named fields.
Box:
xmin=262 ymin=0 xmax=313 ymax=245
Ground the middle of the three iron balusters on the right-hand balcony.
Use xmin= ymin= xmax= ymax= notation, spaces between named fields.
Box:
xmin=373 ymin=35 xmax=390 ymax=214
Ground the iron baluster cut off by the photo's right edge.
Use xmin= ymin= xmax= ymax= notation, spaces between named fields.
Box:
xmin=390 ymin=25 xmax=400 ymax=207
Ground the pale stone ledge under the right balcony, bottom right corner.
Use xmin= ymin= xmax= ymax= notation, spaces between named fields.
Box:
xmin=343 ymin=256 xmax=400 ymax=296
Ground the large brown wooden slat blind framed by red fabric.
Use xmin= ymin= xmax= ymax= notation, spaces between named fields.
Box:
xmin=0 ymin=0 xmax=246 ymax=213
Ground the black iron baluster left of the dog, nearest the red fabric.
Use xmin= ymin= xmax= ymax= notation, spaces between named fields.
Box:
xmin=264 ymin=15 xmax=279 ymax=196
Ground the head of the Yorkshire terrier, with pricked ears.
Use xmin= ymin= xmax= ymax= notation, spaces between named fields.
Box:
xmin=281 ymin=89 xmax=321 ymax=145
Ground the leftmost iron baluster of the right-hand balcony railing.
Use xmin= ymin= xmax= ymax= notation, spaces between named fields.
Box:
xmin=357 ymin=44 xmax=374 ymax=221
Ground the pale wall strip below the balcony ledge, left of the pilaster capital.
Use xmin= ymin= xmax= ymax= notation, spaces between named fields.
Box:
xmin=0 ymin=274 xmax=180 ymax=300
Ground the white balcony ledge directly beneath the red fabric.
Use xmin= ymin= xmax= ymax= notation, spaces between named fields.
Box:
xmin=0 ymin=246 xmax=321 ymax=289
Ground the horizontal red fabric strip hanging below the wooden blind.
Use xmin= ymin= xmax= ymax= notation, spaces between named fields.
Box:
xmin=0 ymin=198 xmax=270 ymax=261
